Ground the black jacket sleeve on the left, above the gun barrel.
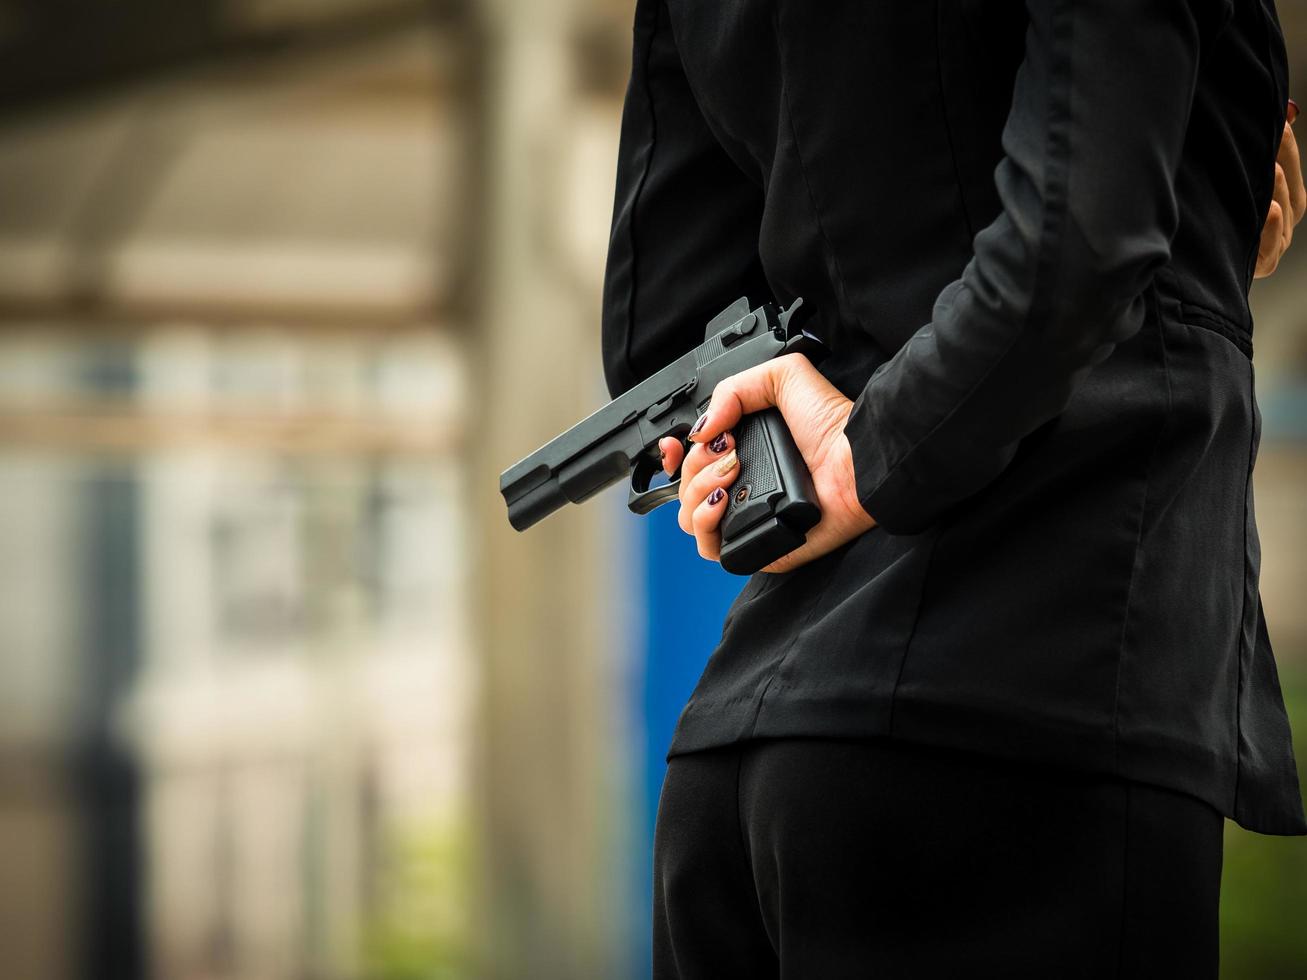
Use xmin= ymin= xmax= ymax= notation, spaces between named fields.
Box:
xmin=603 ymin=0 xmax=766 ymax=397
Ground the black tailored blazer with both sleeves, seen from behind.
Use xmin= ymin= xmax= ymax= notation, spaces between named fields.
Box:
xmin=603 ymin=0 xmax=1307 ymax=834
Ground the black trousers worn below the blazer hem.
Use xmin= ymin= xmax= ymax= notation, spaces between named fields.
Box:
xmin=654 ymin=738 xmax=1223 ymax=980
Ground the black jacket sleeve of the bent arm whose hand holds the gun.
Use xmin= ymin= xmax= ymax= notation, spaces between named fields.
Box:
xmin=846 ymin=0 xmax=1222 ymax=533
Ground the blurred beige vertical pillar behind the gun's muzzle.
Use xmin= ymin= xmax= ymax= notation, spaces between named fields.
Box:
xmin=469 ymin=0 xmax=626 ymax=979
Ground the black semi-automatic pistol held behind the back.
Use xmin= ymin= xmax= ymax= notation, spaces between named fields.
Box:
xmin=499 ymin=297 xmax=827 ymax=575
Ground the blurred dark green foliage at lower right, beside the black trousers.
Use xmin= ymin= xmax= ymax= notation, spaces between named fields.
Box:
xmin=1221 ymin=668 xmax=1307 ymax=980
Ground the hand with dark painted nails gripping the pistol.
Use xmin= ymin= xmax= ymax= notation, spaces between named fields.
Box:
xmin=659 ymin=354 xmax=876 ymax=572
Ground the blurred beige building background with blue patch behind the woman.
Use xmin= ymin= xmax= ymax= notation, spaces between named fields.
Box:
xmin=0 ymin=0 xmax=1307 ymax=980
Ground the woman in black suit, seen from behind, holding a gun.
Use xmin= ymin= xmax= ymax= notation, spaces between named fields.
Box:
xmin=604 ymin=0 xmax=1307 ymax=977
